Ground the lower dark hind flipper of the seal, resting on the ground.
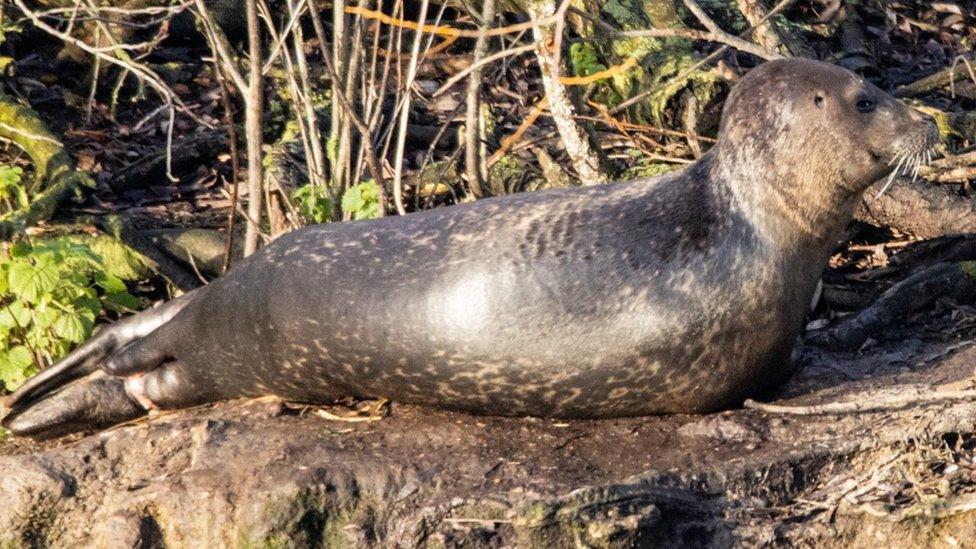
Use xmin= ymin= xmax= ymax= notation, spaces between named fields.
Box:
xmin=2 ymin=377 xmax=146 ymax=438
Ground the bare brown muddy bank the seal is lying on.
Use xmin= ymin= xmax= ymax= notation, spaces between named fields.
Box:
xmin=0 ymin=304 xmax=976 ymax=547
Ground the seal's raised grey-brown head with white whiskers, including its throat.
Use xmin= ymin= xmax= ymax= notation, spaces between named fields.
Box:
xmin=715 ymin=59 xmax=939 ymax=240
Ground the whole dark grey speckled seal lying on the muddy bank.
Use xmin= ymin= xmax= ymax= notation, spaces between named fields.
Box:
xmin=3 ymin=60 xmax=938 ymax=436
